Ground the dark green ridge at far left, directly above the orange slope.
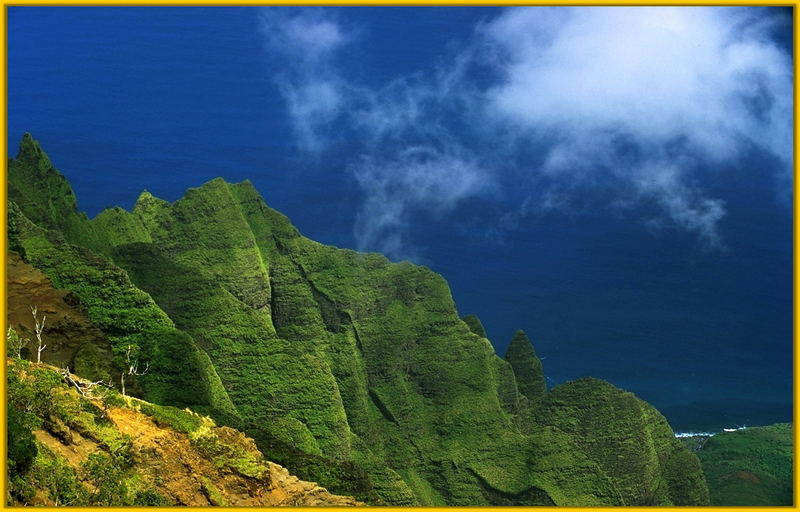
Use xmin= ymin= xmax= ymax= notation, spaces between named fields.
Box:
xmin=8 ymin=145 xmax=236 ymax=424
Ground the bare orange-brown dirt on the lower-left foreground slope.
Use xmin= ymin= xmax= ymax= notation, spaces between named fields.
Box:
xmin=10 ymin=363 xmax=361 ymax=506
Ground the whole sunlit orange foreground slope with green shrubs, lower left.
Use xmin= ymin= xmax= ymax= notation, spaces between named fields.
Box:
xmin=9 ymin=360 xmax=358 ymax=506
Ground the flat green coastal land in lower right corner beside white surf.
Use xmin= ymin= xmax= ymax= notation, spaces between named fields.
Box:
xmin=697 ymin=423 xmax=793 ymax=507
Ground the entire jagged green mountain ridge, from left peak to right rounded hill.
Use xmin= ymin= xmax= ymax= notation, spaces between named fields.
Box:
xmin=8 ymin=135 xmax=708 ymax=506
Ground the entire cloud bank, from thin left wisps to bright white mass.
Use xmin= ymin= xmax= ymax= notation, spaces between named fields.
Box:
xmin=262 ymin=7 xmax=792 ymax=257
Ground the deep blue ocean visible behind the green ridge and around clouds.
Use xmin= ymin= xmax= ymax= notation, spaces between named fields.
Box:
xmin=8 ymin=7 xmax=792 ymax=430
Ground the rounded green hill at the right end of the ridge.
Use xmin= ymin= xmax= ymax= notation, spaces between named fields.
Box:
xmin=535 ymin=378 xmax=708 ymax=505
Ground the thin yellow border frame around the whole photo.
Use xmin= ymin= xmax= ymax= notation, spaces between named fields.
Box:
xmin=0 ymin=0 xmax=800 ymax=512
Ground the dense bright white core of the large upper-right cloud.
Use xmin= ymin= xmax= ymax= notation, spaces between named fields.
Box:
xmin=483 ymin=7 xmax=791 ymax=159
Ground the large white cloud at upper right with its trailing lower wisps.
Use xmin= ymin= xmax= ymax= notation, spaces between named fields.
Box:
xmin=481 ymin=7 xmax=792 ymax=245
